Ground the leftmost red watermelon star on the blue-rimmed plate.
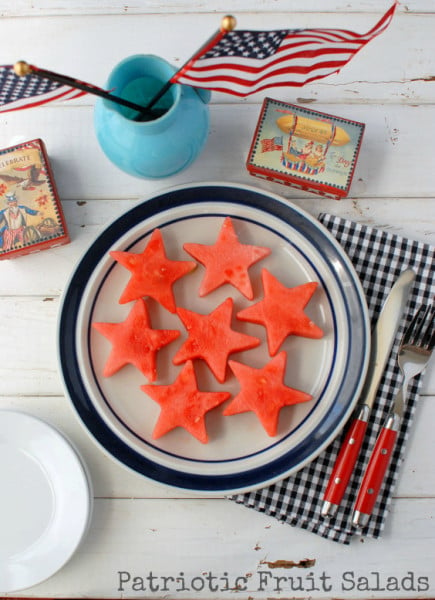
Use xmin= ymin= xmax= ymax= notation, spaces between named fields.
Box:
xmin=92 ymin=299 xmax=180 ymax=381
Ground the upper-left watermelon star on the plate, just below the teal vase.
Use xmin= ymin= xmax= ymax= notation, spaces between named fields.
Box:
xmin=110 ymin=229 xmax=196 ymax=313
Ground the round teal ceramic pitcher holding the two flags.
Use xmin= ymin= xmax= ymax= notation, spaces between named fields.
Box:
xmin=94 ymin=55 xmax=210 ymax=179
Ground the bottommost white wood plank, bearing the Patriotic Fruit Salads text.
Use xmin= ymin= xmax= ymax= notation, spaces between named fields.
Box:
xmin=11 ymin=499 xmax=435 ymax=600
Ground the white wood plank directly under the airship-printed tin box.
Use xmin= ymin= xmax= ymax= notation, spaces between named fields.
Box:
xmin=0 ymin=103 xmax=435 ymax=204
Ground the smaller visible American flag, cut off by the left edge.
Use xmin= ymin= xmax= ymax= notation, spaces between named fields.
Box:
xmin=0 ymin=65 xmax=86 ymax=112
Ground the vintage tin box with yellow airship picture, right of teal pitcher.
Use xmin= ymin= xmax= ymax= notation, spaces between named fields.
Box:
xmin=246 ymin=98 xmax=365 ymax=199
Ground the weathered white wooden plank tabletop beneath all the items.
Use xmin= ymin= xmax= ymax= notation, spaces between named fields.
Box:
xmin=0 ymin=0 xmax=435 ymax=599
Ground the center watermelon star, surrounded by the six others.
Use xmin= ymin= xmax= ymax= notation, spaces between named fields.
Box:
xmin=173 ymin=298 xmax=260 ymax=383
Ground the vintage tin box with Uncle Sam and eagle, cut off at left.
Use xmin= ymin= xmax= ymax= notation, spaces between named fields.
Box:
xmin=0 ymin=139 xmax=69 ymax=260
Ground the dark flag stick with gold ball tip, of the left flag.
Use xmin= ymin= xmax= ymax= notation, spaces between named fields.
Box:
xmin=14 ymin=60 xmax=164 ymax=119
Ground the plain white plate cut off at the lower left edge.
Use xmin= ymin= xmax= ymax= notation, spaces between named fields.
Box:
xmin=0 ymin=410 xmax=92 ymax=593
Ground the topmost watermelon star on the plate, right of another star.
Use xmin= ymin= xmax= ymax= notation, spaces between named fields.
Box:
xmin=183 ymin=217 xmax=271 ymax=300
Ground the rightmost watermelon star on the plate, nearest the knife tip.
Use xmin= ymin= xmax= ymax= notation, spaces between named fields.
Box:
xmin=237 ymin=269 xmax=323 ymax=356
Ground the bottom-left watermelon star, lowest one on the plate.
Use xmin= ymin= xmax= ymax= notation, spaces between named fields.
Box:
xmin=141 ymin=360 xmax=231 ymax=444
